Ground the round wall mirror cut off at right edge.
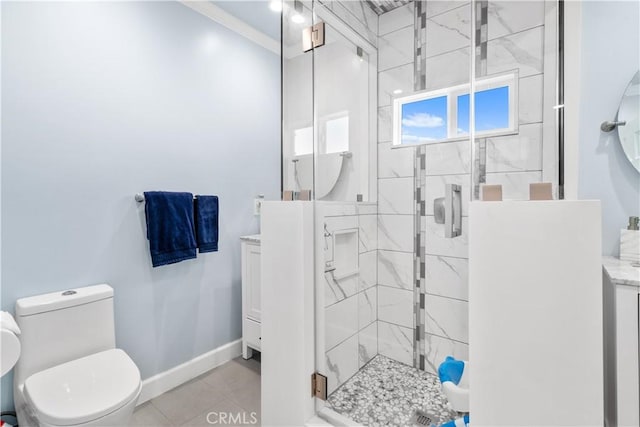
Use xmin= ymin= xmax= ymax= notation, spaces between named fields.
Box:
xmin=618 ymin=71 xmax=640 ymax=172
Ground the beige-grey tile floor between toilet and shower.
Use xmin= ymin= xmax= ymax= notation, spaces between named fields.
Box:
xmin=129 ymin=357 xmax=260 ymax=427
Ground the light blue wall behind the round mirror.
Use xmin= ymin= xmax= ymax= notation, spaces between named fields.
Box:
xmin=580 ymin=1 xmax=640 ymax=255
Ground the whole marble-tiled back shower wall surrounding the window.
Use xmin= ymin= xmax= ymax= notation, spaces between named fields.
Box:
xmin=378 ymin=1 xmax=555 ymax=372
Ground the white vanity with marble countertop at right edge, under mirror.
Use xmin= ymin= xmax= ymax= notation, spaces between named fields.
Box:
xmin=603 ymin=257 xmax=640 ymax=427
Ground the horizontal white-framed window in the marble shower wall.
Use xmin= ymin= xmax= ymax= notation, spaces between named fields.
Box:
xmin=393 ymin=73 xmax=518 ymax=145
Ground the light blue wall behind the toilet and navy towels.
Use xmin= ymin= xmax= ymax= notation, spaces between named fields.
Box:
xmin=1 ymin=2 xmax=280 ymax=410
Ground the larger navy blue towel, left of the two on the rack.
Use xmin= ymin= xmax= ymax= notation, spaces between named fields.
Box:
xmin=144 ymin=191 xmax=196 ymax=267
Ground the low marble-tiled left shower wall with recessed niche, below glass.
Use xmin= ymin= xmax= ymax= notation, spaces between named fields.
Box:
xmin=319 ymin=202 xmax=378 ymax=393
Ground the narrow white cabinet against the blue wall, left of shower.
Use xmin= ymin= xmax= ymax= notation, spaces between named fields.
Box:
xmin=240 ymin=235 xmax=262 ymax=359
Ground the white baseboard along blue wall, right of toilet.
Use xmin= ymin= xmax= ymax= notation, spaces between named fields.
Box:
xmin=138 ymin=339 xmax=242 ymax=405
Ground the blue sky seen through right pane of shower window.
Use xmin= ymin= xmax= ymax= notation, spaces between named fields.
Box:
xmin=458 ymin=86 xmax=509 ymax=135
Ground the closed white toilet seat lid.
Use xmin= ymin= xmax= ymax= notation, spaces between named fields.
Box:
xmin=24 ymin=349 xmax=140 ymax=426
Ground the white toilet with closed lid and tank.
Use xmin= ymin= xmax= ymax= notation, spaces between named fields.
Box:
xmin=13 ymin=284 xmax=141 ymax=427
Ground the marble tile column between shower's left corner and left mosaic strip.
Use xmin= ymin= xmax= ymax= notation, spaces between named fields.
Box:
xmin=378 ymin=2 xmax=415 ymax=365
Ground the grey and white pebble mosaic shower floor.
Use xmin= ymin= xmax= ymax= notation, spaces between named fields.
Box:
xmin=327 ymin=355 xmax=457 ymax=426
